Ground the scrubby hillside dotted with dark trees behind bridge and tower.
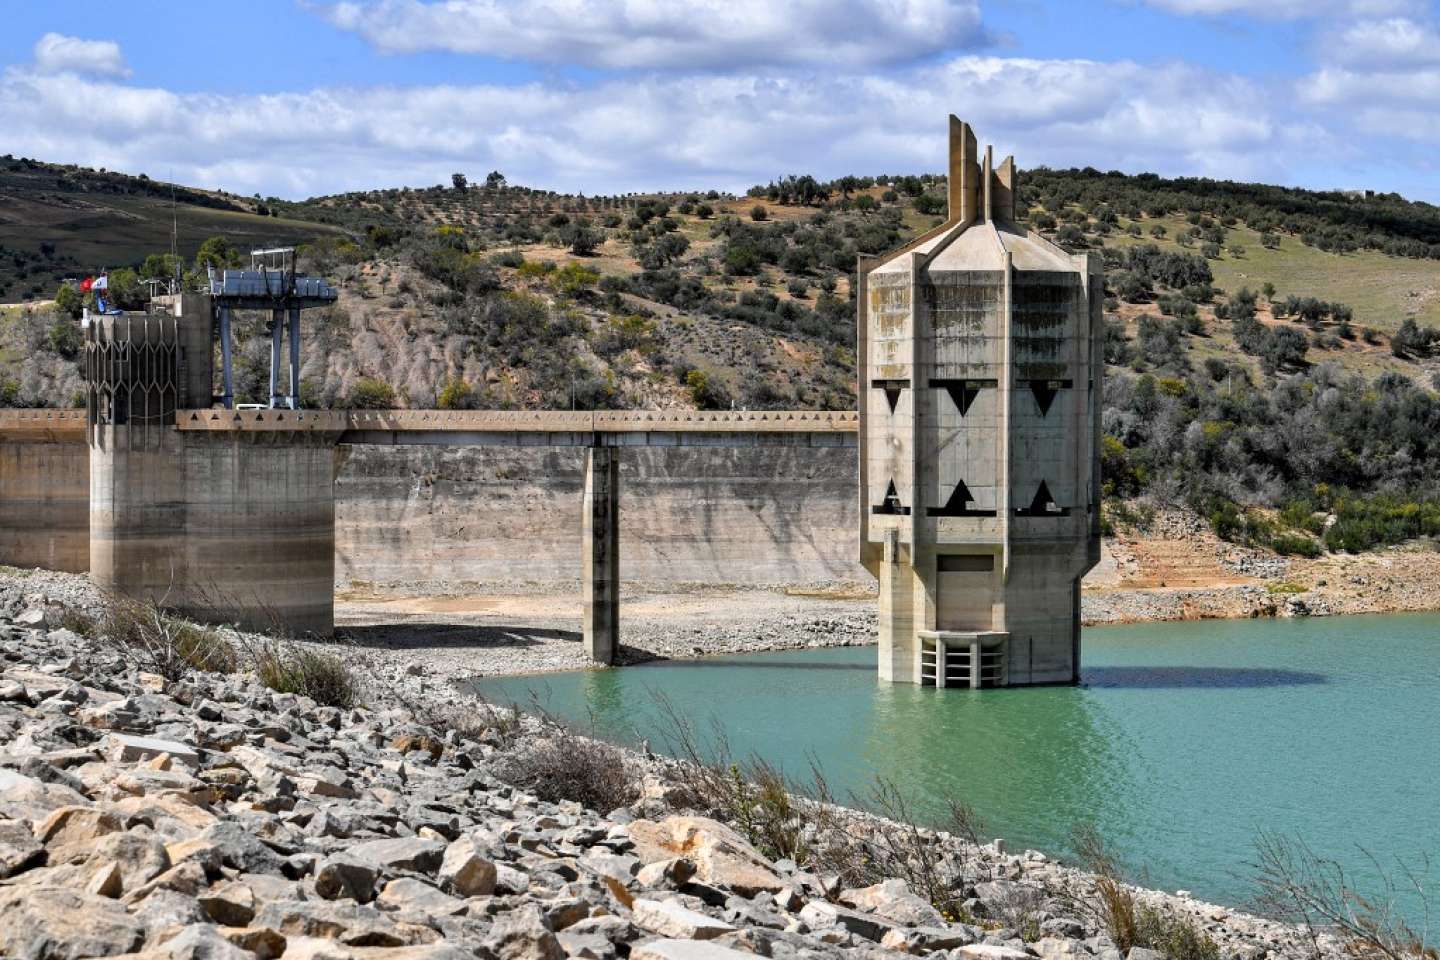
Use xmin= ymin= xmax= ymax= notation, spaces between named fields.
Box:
xmin=8 ymin=161 xmax=1440 ymax=554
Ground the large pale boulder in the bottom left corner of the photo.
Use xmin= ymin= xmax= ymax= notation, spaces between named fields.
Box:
xmin=0 ymin=887 xmax=145 ymax=960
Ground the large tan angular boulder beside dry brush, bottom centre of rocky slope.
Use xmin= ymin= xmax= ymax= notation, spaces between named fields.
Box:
xmin=628 ymin=816 xmax=785 ymax=897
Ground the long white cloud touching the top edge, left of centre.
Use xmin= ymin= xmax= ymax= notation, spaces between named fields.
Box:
xmin=327 ymin=0 xmax=984 ymax=72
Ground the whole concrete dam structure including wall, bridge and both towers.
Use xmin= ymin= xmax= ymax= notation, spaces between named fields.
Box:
xmin=0 ymin=117 xmax=1104 ymax=688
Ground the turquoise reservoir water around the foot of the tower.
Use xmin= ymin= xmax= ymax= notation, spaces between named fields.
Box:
xmin=477 ymin=615 xmax=1440 ymax=908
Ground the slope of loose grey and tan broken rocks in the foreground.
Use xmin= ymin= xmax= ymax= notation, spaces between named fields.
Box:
xmin=0 ymin=593 xmax=1336 ymax=960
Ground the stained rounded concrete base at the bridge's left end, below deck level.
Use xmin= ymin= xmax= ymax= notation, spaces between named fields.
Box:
xmin=89 ymin=426 xmax=336 ymax=635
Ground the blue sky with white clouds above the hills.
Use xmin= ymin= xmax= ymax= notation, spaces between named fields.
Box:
xmin=0 ymin=0 xmax=1440 ymax=204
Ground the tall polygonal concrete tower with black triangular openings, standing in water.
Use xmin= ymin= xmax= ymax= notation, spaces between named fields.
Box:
xmin=857 ymin=117 xmax=1104 ymax=687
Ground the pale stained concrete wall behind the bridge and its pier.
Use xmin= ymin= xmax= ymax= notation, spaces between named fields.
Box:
xmin=0 ymin=439 xmax=868 ymax=592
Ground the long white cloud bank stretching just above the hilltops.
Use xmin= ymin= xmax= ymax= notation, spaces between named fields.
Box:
xmin=0 ymin=56 xmax=1323 ymax=196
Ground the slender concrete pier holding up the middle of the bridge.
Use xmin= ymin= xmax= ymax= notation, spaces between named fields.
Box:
xmin=580 ymin=446 xmax=621 ymax=664
